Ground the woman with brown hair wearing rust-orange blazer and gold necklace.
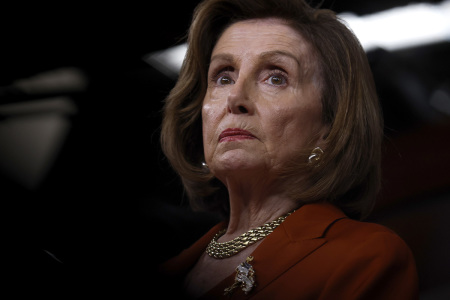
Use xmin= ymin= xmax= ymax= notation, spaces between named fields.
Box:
xmin=161 ymin=0 xmax=417 ymax=299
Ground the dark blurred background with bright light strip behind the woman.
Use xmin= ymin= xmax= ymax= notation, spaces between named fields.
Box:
xmin=0 ymin=0 xmax=450 ymax=299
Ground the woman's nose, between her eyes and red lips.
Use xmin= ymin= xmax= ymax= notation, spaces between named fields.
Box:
xmin=227 ymin=78 xmax=253 ymax=114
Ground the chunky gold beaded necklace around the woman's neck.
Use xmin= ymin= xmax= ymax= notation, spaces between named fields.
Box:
xmin=206 ymin=210 xmax=295 ymax=259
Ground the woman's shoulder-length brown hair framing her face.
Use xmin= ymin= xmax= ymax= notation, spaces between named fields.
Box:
xmin=161 ymin=0 xmax=383 ymax=219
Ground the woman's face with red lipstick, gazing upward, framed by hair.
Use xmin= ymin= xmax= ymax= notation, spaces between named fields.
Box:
xmin=202 ymin=19 xmax=327 ymax=181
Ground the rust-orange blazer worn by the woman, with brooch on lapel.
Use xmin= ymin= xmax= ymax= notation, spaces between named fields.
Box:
xmin=162 ymin=204 xmax=418 ymax=300
